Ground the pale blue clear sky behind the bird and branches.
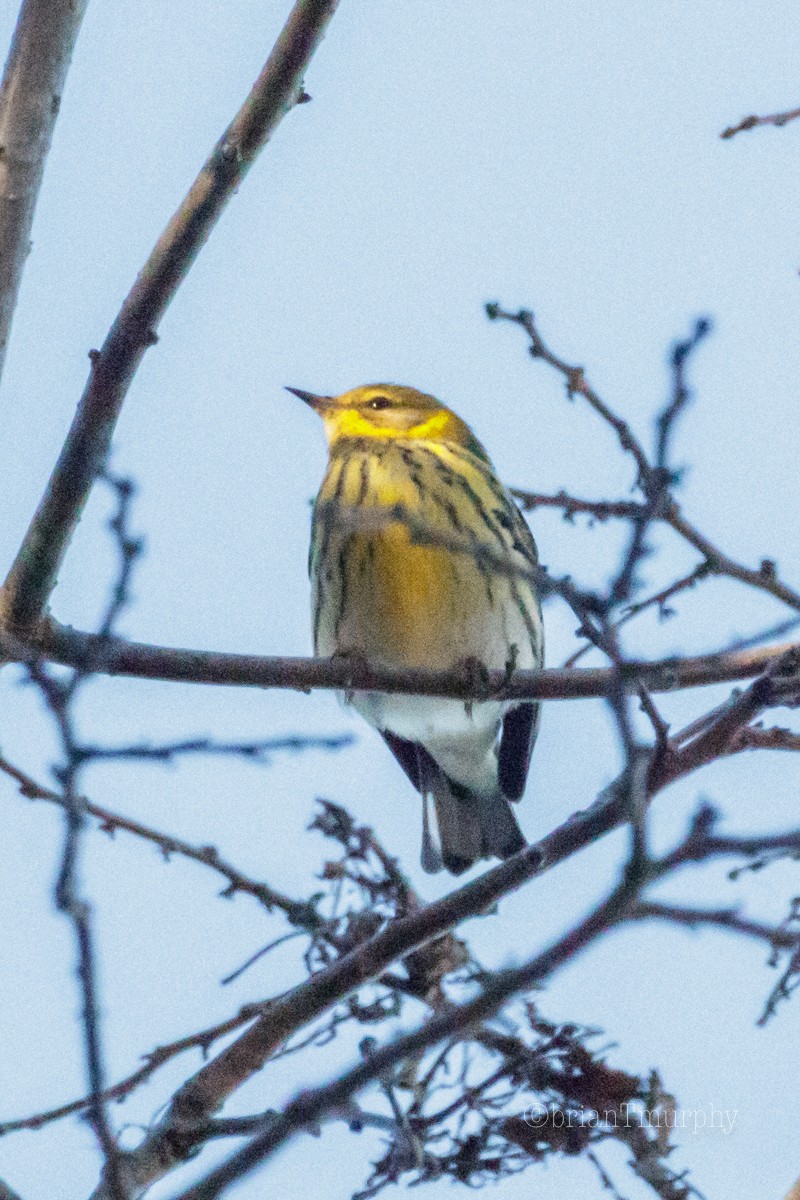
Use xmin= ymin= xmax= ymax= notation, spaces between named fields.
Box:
xmin=0 ymin=0 xmax=800 ymax=1200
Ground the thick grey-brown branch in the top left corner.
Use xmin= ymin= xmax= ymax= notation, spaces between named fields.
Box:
xmin=0 ymin=0 xmax=86 ymax=376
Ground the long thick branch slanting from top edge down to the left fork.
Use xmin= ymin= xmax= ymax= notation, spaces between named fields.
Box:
xmin=0 ymin=0 xmax=337 ymax=629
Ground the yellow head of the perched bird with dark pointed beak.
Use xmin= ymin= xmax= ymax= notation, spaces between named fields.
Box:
xmin=287 ymin=383 xmax=486 ymax=458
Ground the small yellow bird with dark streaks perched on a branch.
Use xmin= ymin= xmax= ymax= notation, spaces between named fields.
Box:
xmin=287 ymin=383 xmax=543 ymax=875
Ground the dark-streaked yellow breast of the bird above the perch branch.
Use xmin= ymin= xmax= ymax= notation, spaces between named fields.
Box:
xmin=311 ymin=443 xmax=536 ymax=668
